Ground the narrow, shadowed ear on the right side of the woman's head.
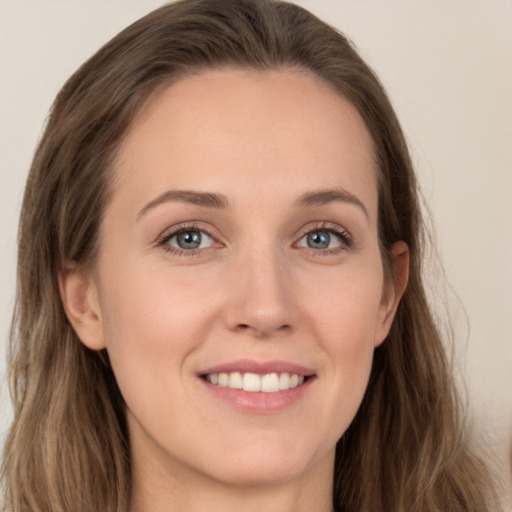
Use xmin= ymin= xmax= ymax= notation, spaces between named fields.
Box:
xmin=375 ymin=241 xmax=409 ymax=347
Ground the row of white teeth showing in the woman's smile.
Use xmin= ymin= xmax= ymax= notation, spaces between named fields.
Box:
xmin=205 ymin=372 xmax=304 ymax=393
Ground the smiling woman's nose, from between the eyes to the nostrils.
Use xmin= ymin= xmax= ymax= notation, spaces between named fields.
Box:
xmin=224 ymin=248 xmax=297 ymax=338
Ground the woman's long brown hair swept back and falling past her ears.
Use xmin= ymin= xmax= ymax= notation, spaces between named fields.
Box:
xmin=2 ymin=0 xmax=492 ymax=512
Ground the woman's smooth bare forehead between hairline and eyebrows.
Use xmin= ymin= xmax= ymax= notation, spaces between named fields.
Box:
xmin=114 ymin=69 xmax=376 ymax=218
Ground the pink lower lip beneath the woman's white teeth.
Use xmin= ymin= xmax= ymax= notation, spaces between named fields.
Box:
xmin=200 ymin=377 xmax=315 ymax=414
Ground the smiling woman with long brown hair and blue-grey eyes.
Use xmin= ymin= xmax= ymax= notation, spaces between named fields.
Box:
xmin=3 ymin=0 xmax=492 ymax=512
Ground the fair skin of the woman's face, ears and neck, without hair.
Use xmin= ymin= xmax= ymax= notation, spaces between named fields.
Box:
xmin=61 ymin=70 xmax=407 ymax=512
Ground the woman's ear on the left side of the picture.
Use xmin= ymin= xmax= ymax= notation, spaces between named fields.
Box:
xmin=59 ymin=263 xmax=106 ymax=350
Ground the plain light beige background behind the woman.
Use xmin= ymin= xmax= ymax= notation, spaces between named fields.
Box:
xmin=0 ymin=0 xmax=512 ymax=504
